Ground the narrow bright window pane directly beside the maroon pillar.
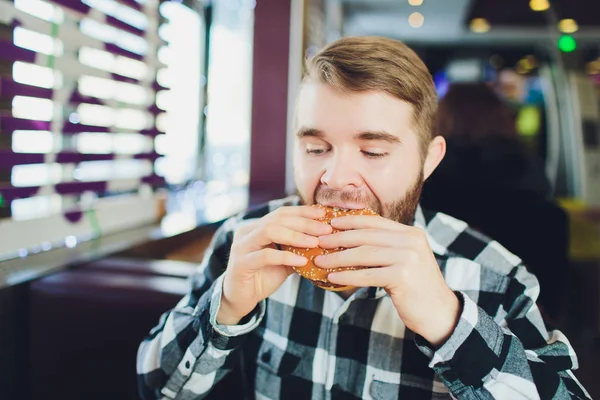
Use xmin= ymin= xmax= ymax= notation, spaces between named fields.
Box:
xmin=204 ymin=0 xmax=256 ymax=219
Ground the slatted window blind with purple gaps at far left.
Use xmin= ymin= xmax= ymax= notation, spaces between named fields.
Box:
xmin=0 ymin=0 xmax=167 ymax=259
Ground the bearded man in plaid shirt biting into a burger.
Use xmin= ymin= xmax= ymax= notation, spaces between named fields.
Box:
xmin=137 ymin=37 xmax=589 ymax=399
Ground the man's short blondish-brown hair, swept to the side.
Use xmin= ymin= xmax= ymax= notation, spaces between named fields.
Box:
xmin=303 ymin=36 xmax=437 ymax=155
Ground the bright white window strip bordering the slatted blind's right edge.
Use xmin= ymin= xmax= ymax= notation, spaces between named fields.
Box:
xmin=156 ymin=2 xmax=206 ymax=185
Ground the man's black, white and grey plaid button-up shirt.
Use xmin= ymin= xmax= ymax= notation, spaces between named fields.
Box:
xmin=137 ymin=197 xmax=590 ymax=400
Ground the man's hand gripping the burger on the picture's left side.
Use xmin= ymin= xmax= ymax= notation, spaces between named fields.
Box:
xmin=217 ymin=206 xmax=332 ymax=325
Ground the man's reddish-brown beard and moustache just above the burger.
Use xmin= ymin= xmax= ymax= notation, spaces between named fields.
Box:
xmin=296 ymin=170 xmax=424 ymax=225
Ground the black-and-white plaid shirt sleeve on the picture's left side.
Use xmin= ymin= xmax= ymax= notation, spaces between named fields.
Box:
xmin=137 ymin=220 xmax=265 ymax=400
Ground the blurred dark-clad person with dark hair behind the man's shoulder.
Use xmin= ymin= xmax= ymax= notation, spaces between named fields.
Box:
xmin=421 ymin=83 xmax=569 ymax=319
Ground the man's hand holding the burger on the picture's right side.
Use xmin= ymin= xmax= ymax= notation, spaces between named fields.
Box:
xmin=315 ymin=215 xmax=461 ymax=346
